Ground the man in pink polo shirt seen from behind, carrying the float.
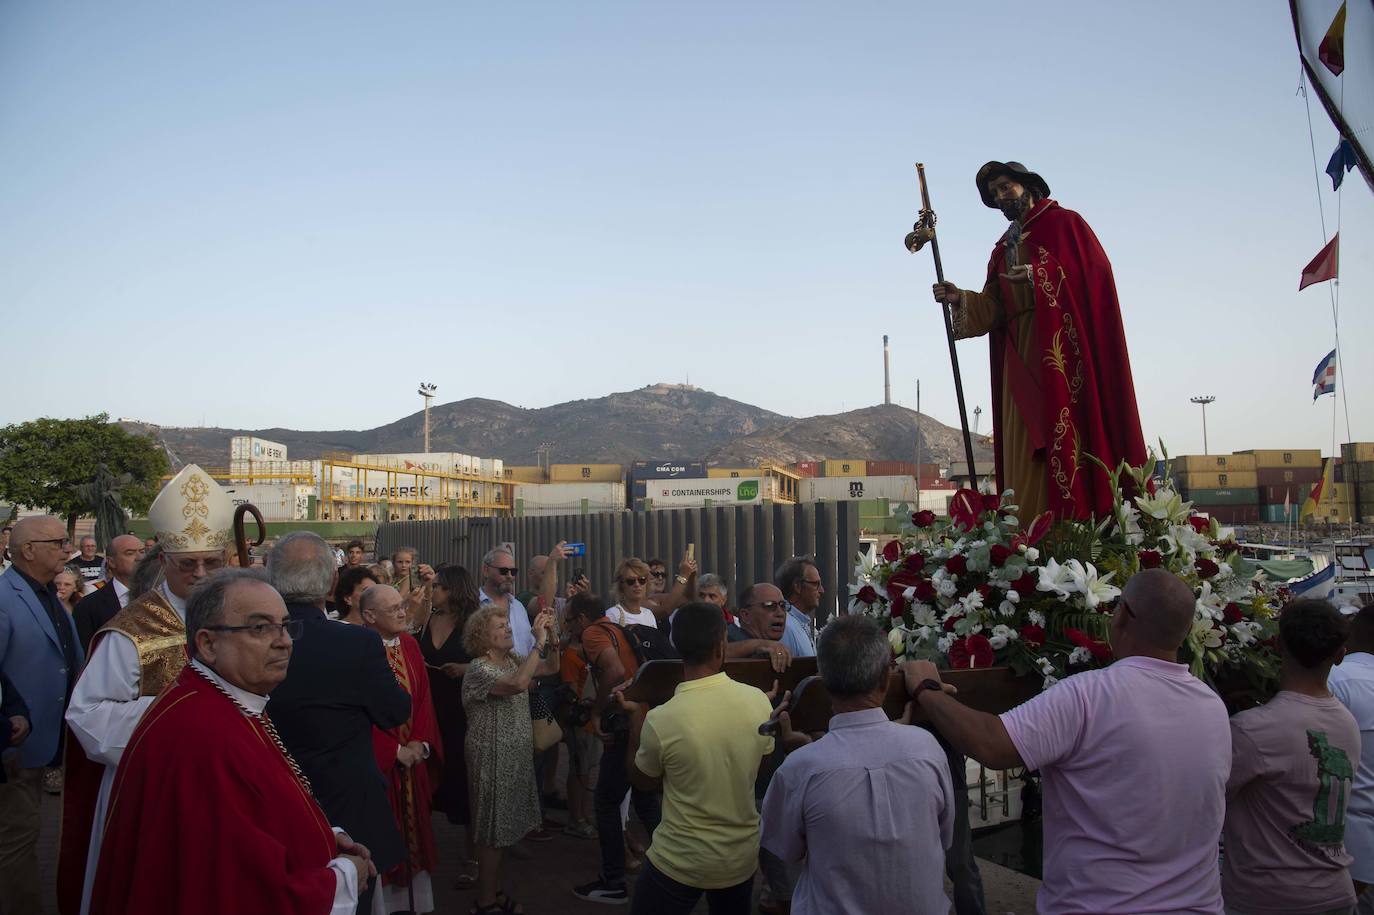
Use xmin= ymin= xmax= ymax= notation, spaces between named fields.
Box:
xmin=904 ymin=569 xmax=1231 ymax=915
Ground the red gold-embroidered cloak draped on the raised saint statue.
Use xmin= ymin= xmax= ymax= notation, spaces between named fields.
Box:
xmin=988 ymin=199 xmax=1146 ymax=521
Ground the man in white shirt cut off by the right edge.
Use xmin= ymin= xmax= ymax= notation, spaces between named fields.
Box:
xmin=1326 ymin=607 xmax=1374 ymax=915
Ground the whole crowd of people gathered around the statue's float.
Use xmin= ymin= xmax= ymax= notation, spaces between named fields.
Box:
xmin=0 ymin=466 xmax=1374 ymax=915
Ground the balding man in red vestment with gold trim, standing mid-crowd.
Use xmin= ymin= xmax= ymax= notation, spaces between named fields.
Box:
xmin=359 ymin=585 xmax=444 ymax=915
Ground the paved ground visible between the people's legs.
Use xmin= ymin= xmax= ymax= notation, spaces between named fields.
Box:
xmin=38 ymin=780 xmax=1040 ymax=915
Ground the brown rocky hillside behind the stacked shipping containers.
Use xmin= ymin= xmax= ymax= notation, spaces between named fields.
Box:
xmin=122 ymin=385 xmax=987 ymax=467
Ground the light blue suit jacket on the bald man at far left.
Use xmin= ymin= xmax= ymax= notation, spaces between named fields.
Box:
xmin=0 ymin=566 xmax=85 ymax=769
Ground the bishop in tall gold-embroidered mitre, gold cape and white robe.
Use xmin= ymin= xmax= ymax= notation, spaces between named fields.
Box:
xmin=58 ymin=464 xmax=234 ymax=915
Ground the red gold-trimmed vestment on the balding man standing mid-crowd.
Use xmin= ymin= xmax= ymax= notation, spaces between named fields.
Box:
xmin=372 ymin=632 xmax=444 ymax=886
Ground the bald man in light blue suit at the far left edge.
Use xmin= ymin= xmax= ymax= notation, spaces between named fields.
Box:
xmin=0 ymin=515 xmax=84 ymax=915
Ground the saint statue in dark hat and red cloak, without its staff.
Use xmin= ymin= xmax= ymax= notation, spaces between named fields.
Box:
xmin=934 ymin=162 xmax=1146 ymax=522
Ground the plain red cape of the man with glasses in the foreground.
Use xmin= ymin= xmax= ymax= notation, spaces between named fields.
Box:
xmin=91 ymin=666 xmax=337 ymax=915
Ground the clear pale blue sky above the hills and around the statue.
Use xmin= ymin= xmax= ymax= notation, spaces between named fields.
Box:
xmin=0 ymin=0 xmax=1374 ymax=453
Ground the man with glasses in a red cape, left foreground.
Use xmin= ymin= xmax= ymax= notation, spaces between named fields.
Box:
xmin=91 ymin=569 xmax=372 ymax=915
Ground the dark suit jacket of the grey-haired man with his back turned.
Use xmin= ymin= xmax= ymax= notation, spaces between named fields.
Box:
xmin=267 ymin=603 xmax=411 ymax=872
